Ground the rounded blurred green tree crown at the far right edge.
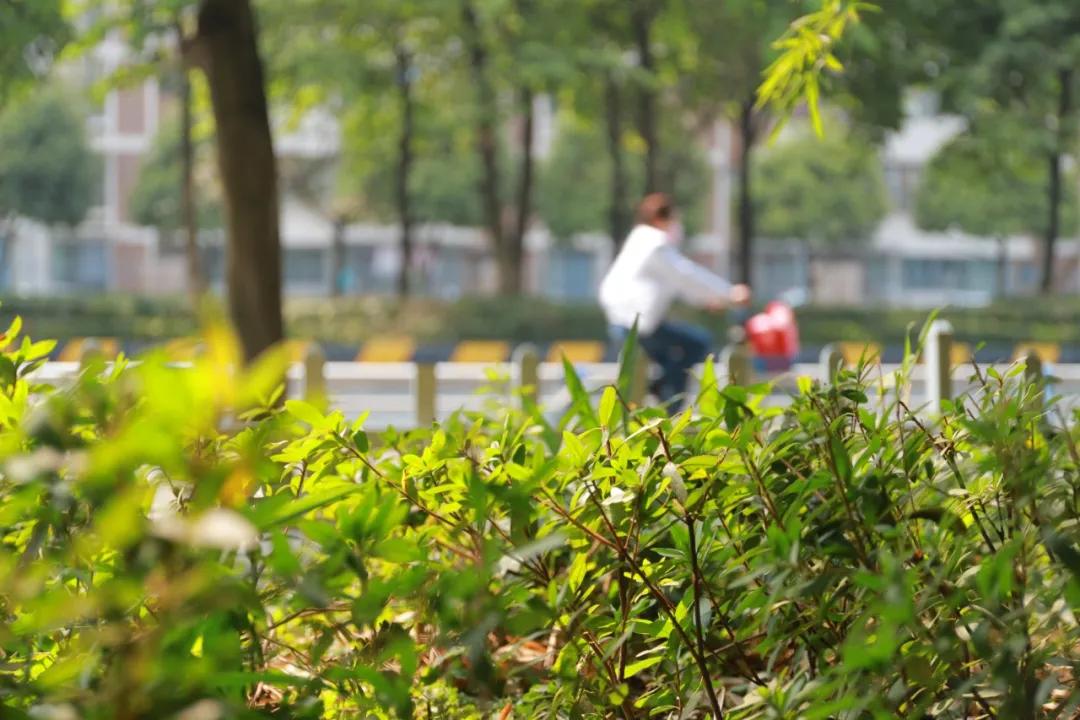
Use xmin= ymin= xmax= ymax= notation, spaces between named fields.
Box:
xmin=915 ymin=133 xmax=1080 ymax=237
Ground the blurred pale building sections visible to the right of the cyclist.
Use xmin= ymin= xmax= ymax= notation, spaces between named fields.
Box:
xmin=692 ymin=92 xmax=1080 ymax=308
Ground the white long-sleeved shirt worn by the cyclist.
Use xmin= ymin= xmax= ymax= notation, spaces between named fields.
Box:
xmin=600 ymin=225 xmax=731 ymax=335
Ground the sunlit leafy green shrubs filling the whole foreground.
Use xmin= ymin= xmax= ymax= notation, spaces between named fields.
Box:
xmin=0 ymin=317 xmax=1080 ymax=720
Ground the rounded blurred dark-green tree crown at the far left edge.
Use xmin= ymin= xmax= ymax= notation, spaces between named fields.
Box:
xmin=0 ymin=86 xmax=99 ymax=226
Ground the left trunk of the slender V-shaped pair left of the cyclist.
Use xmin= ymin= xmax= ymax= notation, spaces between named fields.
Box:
xmin=461 ymin=0 xmax=521 ymax=295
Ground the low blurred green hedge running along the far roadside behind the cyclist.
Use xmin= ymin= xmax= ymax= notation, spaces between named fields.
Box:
xmin=6 ymin=296 xmax=1080 ymax=347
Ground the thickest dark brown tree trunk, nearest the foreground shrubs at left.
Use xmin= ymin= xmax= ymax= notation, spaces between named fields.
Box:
xmin=198 ymin=0 xmax=284 ymax=362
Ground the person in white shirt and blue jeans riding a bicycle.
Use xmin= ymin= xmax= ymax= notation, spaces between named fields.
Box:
xmin=599 ymin=193 xmax=751 ymax=410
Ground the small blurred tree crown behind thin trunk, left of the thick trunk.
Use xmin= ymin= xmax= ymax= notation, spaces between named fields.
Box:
xmin=129 ymin=117 xmax=222 ymax=232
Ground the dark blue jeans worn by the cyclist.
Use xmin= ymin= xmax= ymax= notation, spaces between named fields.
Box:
xmin=608 ymin=321 xmax=713 ymax=412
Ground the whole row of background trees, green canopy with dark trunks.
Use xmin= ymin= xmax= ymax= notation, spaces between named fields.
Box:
xmin=0 ymin=0 xmax=1080 ymax=354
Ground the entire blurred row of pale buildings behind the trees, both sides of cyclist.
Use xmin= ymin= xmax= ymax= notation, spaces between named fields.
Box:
xmin=0 ymin=62 xmax=1080 ymax=307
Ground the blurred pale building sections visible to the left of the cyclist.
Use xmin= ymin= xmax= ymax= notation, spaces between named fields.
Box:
xmin=0 ymin=35 xmax=610 ymax=301
